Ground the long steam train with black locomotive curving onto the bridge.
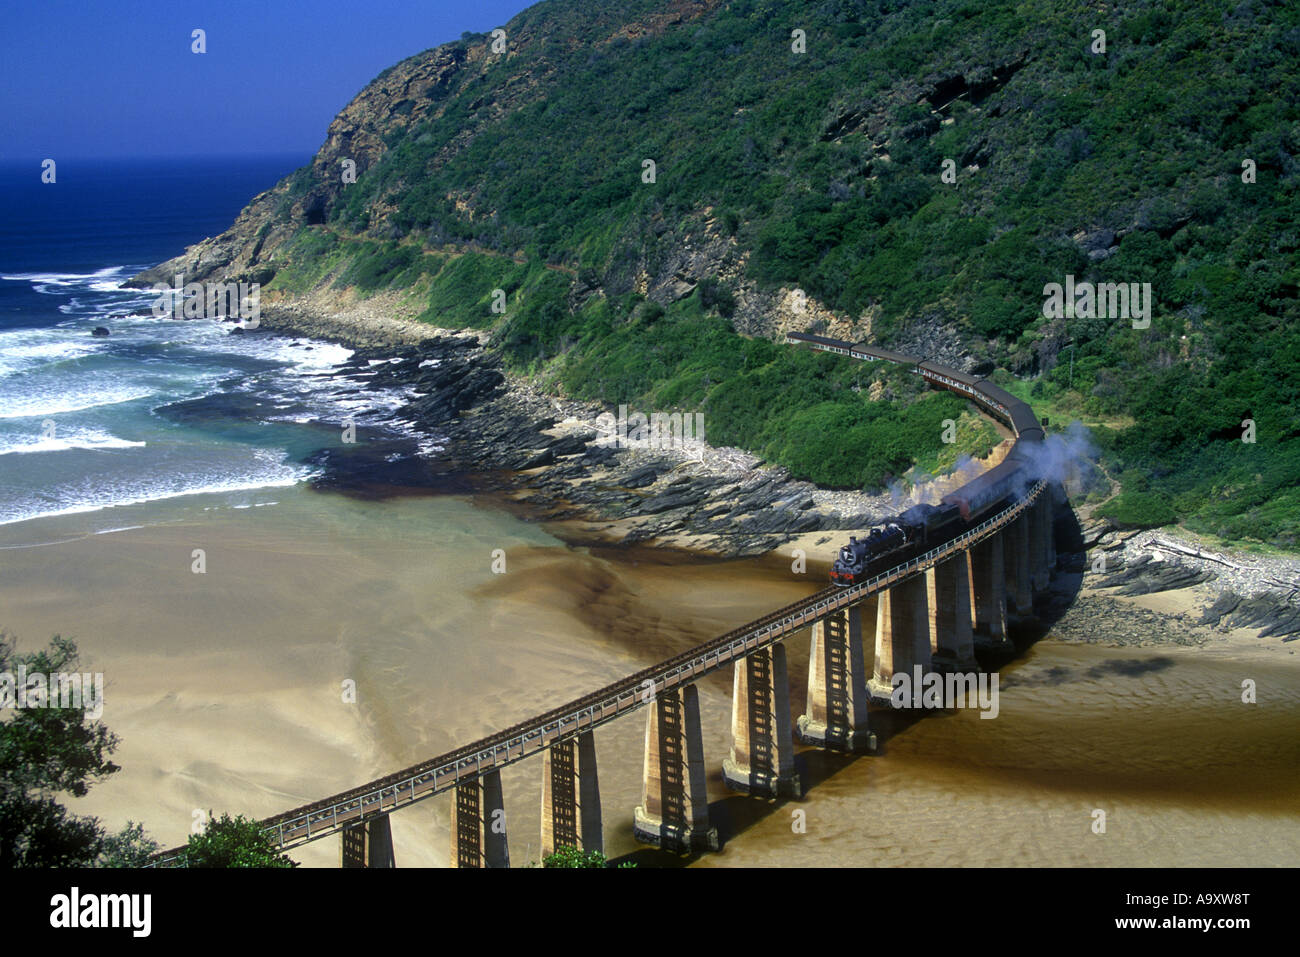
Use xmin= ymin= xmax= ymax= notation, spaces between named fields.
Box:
xmin=785 ymin=333 xmax=1045 ymax=588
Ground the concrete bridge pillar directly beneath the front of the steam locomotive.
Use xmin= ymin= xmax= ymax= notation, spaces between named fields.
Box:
xmin=794 ymin=596 xmax=879 ymax=752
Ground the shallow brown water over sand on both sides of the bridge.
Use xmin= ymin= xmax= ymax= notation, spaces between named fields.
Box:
xmin=0 ymin=490 xmax=1300 ymax=866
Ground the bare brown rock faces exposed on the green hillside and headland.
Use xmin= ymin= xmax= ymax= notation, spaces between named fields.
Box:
xmin=129 ymin=0 xmax=972 ymax=368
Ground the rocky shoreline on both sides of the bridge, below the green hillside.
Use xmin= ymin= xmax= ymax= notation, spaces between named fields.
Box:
xmin=248 ymin=306 xmax=1300 ymax=644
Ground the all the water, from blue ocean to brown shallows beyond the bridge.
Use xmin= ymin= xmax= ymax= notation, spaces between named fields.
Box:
xmin=0 ymin=157 xmax=1300 ymax=867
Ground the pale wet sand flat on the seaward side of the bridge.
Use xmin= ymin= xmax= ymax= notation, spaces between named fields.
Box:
xmin=0 ymin=489 xmax=810 ymax=865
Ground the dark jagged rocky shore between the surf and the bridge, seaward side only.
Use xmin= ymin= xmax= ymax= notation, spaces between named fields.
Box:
xmin=263 ymin=309 xmax=906 ymax=558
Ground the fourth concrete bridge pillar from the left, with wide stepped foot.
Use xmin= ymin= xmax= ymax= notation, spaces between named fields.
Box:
xmin=632 ymin=684 xmax=718 ymax=852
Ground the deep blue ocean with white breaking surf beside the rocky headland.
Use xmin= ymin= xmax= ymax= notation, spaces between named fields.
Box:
xmin=0 ymin=156 xmax=416 ymax=527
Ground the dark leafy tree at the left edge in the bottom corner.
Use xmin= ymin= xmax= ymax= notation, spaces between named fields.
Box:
xmin=0 ymin=632 xmax=122 ymax=870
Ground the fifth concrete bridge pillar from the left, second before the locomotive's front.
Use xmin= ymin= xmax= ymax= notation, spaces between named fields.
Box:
xmin=723 ymin=645 xmax=803 ymax=797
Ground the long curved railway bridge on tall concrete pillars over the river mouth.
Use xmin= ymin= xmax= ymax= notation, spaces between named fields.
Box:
xmin=153 ymin=333 xmax=1063 ymax=867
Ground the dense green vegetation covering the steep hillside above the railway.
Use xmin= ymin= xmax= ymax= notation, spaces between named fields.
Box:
xmin=266 ymin=0 xmax=1300 ymax=547
